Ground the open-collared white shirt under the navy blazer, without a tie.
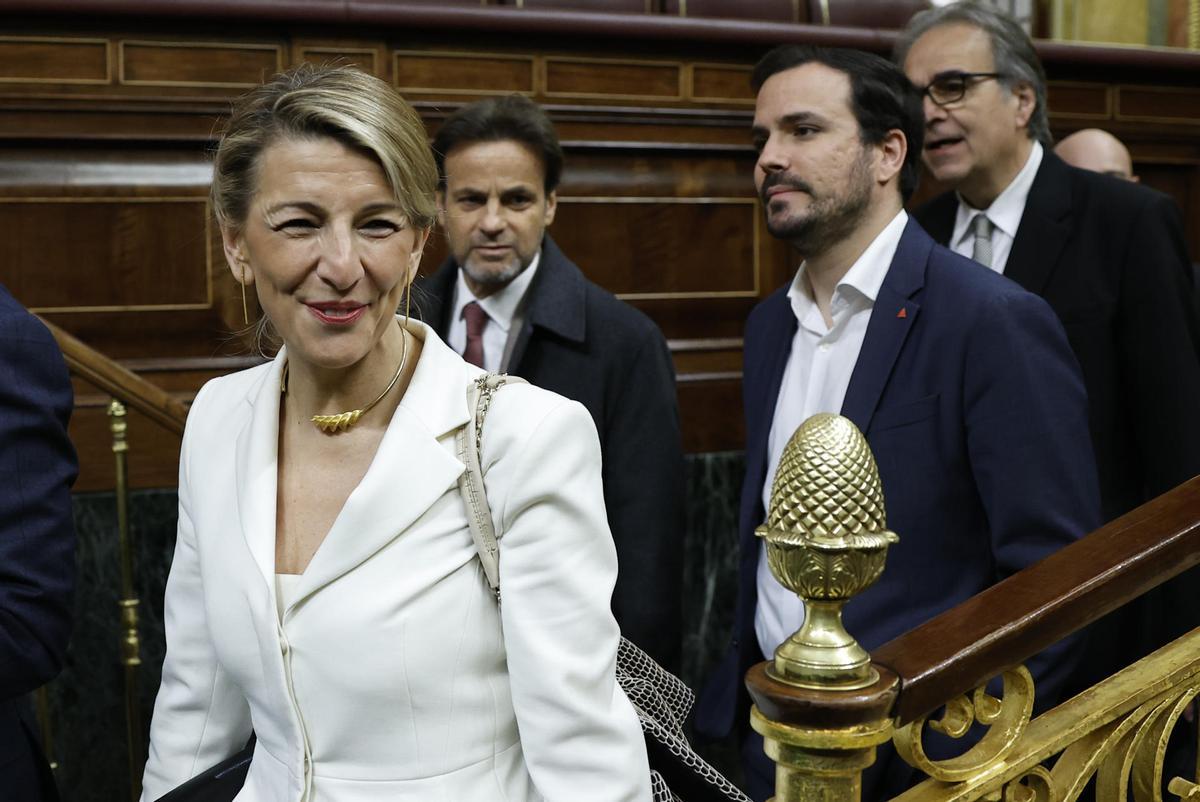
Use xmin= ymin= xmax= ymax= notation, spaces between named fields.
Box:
xmin=754 ymin=210 xmax=908 ymax=658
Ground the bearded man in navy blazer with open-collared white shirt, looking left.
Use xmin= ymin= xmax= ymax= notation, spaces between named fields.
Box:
xmin=696 ymin=46 xmax=1099 ymax=798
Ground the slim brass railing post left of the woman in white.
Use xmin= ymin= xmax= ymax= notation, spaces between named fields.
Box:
xmin=108 ymin=399 xmax=144 ymax=802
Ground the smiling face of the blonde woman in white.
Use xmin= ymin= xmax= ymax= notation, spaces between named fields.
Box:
xmin=222 ymin=137 xmax=428 ymax=370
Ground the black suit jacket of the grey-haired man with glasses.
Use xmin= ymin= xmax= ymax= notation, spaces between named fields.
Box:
xmin=917 ymin=150 xmax=1200 ymax=690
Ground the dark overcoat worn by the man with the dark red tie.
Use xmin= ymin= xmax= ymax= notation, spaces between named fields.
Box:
xmin=415 ymin=234 xmax=684 ymax=670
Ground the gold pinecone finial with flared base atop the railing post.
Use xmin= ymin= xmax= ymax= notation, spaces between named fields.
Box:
xmin=755 ymin=413 xmax=899 ymax=689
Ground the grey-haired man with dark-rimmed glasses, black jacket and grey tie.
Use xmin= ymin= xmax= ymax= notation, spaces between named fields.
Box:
xmin=895 ymin=2 xmax=1200 ymax=705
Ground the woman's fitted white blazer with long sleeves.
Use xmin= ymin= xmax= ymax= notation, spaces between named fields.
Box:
xmin=142 ymin=321 xmax=650 ymax=802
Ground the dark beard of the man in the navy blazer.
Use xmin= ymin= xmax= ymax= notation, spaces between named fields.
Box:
xmin=760 ymin=149 xmax=871 ymax=258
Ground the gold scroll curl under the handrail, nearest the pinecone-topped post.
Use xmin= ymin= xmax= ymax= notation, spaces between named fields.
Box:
xmin=893 ymin=665 xmax=1036 ymax=782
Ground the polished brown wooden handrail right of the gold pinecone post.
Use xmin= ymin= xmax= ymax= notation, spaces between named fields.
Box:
xmin=872 ymin=477 xmax=1200 ymax=724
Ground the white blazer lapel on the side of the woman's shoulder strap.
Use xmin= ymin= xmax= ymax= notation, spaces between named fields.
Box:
xmin=289 ymin=322 xmax=475 ymax=609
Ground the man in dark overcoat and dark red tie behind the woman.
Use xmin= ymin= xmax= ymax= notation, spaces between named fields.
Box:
xmin=418 ymin=95 xmax=684 ymax=670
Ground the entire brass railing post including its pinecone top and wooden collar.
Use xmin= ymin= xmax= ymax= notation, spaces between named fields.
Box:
xmin=746 ymin=414 xmax=898 ymax=802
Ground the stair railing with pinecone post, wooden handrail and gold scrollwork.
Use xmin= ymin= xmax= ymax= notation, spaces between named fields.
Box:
xmin=746 ymin=415 xmax=1200 ymax=802
